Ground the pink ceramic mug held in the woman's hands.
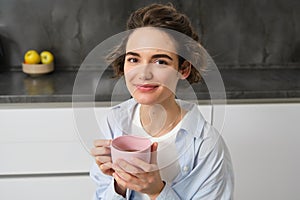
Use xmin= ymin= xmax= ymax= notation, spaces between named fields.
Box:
xmin=111 ymin=135 xmax=152 ymax=163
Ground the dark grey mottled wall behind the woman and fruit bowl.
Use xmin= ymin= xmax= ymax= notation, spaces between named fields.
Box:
xmin=0 ymin=0 xmax=300 ymax=69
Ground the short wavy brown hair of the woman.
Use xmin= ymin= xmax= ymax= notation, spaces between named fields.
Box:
xmin=106 ymin=3 xmax=201 ymax=83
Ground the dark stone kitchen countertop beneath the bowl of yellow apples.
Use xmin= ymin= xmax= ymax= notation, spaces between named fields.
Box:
xmin=0 ymin=69 xmax=300 ymax=103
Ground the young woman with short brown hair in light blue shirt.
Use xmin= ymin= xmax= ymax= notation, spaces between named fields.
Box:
xmin=90 ymin=4 xmax=233 ymax=200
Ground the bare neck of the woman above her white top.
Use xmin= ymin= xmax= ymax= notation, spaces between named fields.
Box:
xmin=140 ymin=99 xmax=184 ymax=137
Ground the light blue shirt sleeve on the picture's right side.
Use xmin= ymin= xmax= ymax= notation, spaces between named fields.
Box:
xmin=170 ymin=125 xmax=234 ymax=200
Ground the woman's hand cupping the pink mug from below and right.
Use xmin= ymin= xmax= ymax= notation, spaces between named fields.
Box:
xmin=113 ymin=143 xmax=164 ymax=199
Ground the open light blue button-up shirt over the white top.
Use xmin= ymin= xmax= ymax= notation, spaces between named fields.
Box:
xmin=90 ymin=99 xmax=234 ymax=200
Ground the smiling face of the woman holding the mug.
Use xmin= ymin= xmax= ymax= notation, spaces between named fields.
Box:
xmin=124 ymin=28 xmax=180 ymax=105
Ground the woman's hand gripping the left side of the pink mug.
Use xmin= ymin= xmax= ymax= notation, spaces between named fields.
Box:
xmin=91 ymin=140 xmax=114 ymax=176
